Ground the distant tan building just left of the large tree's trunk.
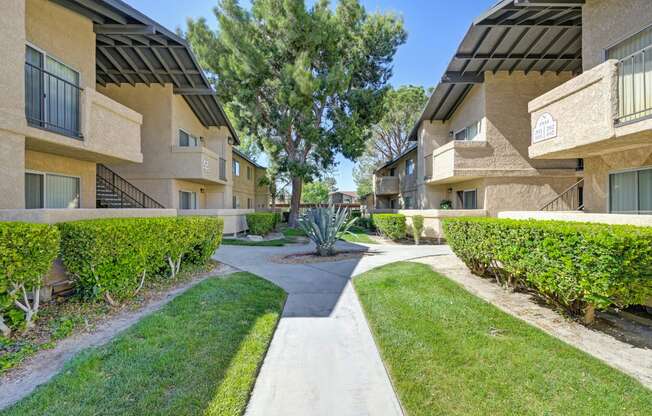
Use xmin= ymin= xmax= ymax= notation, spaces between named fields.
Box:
xmin=230 ymin=147 xmax=270 ymax=209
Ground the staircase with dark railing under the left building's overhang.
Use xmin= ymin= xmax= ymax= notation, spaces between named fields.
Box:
xmin=95 ymin=163 xmax=164 ymax=208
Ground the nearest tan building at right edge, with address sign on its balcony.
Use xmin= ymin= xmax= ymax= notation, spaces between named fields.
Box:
xmin=528 ymin=0 xmax=652 ymax=218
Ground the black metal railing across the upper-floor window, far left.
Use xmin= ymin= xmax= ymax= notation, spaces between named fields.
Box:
xmin=25 ymin=62 xmax=82 ymax=139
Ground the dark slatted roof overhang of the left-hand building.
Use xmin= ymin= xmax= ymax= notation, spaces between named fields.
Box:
xmin=51 ymin=0 xmax=239 ymax=143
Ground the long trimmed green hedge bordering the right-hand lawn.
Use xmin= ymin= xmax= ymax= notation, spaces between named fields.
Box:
xmin=443 ymin=218 xmax=652 ymax=322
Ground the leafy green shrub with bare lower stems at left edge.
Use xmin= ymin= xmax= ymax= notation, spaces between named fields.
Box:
xmin=0 ymin=222 xmax=59 ymax=336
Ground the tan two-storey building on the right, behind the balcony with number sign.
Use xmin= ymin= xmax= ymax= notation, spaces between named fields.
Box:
xmin=410 ymin=0 xmax=582 ymax=216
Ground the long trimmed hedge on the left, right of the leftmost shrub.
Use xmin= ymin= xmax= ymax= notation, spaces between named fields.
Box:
xmin=58 ymin=217 xmax=224 ymax=304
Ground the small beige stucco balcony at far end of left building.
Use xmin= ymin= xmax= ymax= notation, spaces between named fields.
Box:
xmin=168 ymin=146 xmax=227 ymax=184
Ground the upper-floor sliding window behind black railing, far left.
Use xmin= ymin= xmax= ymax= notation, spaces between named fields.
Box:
xmin=25 ymin=46 xmax=81 ymax=138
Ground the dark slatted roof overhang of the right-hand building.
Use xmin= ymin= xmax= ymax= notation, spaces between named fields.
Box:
xmin=410 ymin=0 xmax=584 ymax=140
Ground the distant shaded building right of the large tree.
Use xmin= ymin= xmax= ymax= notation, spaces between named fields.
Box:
xmin=373 ymin=145 xmax=418 ymax=209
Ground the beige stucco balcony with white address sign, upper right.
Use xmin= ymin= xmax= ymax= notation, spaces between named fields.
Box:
xmin=529 ymin=59 xmax=652 ymax=159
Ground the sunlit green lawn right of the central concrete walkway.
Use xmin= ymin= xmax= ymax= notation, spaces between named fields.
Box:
xmin=354 ymin=263 xmax=652 ymax=416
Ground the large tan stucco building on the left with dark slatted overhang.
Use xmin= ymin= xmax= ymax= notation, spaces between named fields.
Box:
xmin=0 ymin=0 xmax=268 ymax=216
